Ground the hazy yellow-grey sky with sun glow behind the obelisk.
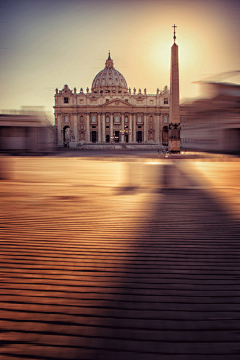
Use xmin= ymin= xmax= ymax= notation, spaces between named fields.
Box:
xmin=0 ymin=0 xmax=240 ymax=122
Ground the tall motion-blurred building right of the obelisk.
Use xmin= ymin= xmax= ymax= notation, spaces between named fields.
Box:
xmin=181 ymin=81 xmax=240 ymax=153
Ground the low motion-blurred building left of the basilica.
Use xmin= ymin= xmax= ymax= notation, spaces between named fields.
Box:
xmin=0 ymin=107 xmax=55 ymax=152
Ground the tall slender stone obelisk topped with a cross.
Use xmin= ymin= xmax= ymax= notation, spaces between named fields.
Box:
xmin=168 ymin=24 xmax=180 ymax=152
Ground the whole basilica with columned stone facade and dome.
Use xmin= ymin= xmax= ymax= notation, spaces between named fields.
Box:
xmin=54 ymin=53 xmax=170 ymax=148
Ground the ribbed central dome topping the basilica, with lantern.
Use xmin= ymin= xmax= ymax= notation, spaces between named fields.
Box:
xmin=92 ymin=53 xmax=127 ymax=90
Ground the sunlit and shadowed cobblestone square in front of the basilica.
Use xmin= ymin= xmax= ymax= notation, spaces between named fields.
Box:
xmin=0 ymin=158 xmax=240 ymax=360
